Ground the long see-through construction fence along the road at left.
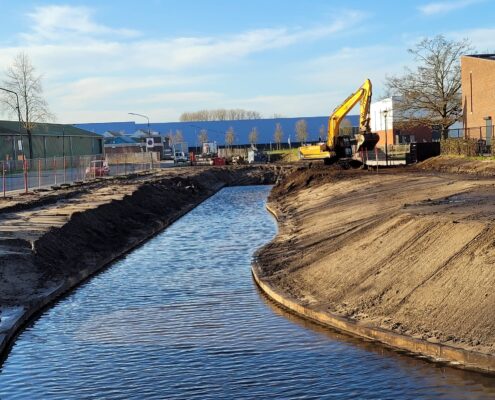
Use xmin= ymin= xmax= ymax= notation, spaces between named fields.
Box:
xmin=0 ymin=152 xmax=159 ymax=197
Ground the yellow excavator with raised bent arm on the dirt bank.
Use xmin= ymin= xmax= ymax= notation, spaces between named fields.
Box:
xmin=299 ymin=79 xmax=379 ymax=164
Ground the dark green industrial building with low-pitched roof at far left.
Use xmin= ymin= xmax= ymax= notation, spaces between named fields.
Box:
xmin=0 ymin=121 xmax=103 ymax=160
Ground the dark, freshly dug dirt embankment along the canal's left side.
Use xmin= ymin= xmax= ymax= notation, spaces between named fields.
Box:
xmin=0 ymin=166 xmax=286 ymax=353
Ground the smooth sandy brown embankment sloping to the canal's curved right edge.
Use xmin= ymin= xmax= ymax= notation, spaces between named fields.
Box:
xmin=256 ymin=161 xmax=495 ymax=370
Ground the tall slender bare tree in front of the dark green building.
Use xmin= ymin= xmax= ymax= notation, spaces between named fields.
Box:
xmin=0 ymin=52 xmax=55 ymax=159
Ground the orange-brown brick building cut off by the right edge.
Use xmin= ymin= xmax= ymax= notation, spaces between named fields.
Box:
xmin=461 ymin=54 xmax=495 ymax=144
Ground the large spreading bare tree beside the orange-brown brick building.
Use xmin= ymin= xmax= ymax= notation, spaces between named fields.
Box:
xmin=386 ymin=35 xmax=473 ymax=138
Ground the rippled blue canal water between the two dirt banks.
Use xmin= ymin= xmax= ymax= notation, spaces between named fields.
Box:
xmin=0 ymin=186 xmax=495 ymax=400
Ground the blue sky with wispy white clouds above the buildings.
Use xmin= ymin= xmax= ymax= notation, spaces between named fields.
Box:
xmin=0 ymin=0 xmax=495 ymax=123
